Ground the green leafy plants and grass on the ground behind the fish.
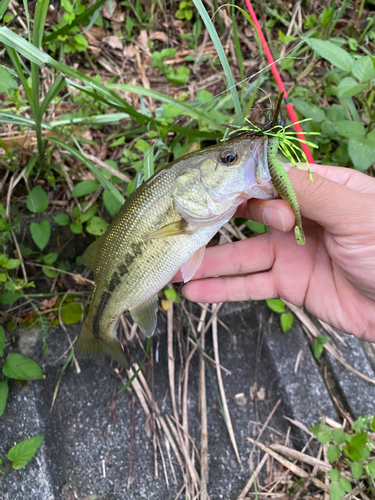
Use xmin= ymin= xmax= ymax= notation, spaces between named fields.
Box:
xmin=0 ymin=0 xmax=375 ymax=498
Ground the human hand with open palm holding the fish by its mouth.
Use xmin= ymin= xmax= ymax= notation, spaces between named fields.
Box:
xmin=183 ymin=165 xmax=375 ymax=342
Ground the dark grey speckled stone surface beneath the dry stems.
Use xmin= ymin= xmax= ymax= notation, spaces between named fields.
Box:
xmin=0 ymin=303 xmax=374 ymax=500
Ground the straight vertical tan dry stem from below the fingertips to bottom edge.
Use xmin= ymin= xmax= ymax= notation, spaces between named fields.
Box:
xmin=197 ymin=309 xmax=209 ymax=500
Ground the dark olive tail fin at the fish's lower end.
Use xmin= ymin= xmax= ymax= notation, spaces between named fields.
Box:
xmin=74 ymin=321 xmax=128 ymax=367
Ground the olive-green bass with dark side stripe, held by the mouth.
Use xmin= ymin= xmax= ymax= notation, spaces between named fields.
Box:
xmin=75 ymin=133 xmax=278 ymax=364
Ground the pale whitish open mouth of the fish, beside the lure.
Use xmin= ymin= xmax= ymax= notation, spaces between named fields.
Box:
xmin=241 ymin=137 xmax=277 ymax=200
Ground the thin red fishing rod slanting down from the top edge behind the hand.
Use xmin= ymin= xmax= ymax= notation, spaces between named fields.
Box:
xmin=245 ymin=0 xmax=315 ymax=163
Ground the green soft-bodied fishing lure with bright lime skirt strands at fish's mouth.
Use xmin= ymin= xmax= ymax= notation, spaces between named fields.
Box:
xmin=222 ymin=93 xmax=318 ymax=245
